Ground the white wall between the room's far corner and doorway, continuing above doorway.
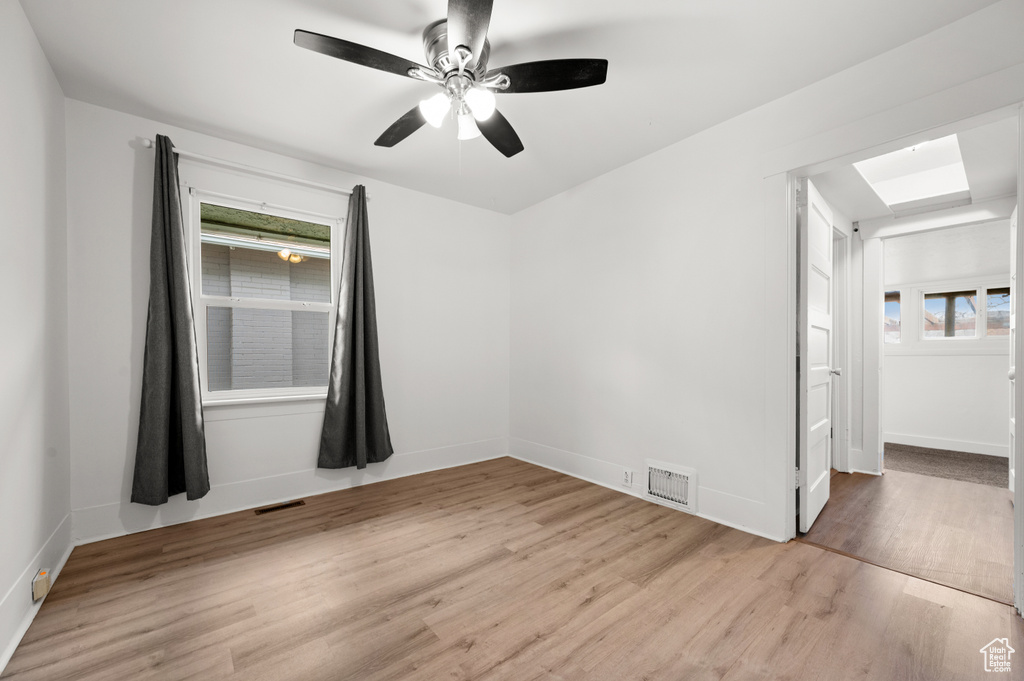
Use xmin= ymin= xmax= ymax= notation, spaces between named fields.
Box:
xmin=510 ymin=2 xmax=1024 ymax=539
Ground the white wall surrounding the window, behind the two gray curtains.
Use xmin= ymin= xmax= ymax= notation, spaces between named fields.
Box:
xmin=68 ymin=100 xmax=511 ymax=540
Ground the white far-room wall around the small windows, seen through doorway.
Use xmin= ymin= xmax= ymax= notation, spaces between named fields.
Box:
xmin=882 ymin=220 xmax=1010 ymax=457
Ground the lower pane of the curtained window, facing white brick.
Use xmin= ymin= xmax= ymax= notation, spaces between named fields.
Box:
xmin=206 ymin=306 xmax=330 ymax=391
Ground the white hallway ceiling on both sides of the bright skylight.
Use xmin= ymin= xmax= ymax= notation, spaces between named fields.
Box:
xmin=811 ymin=117 xmax=1018 ymax=221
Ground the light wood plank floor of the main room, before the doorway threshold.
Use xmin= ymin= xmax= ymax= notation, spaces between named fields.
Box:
xmin=3 ymin=459 xmax=1024 ymax=681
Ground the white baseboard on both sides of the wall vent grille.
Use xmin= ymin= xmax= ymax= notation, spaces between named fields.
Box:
xmin=509 ymin=437 xmax=785 ymax=542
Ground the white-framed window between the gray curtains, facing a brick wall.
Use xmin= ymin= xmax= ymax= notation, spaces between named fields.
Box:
xmin=191 ymin=191 xmax=341 ymax=401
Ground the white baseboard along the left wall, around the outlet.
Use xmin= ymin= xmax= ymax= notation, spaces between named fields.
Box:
xmin=0 ymin=513 xmax=75 ymax=674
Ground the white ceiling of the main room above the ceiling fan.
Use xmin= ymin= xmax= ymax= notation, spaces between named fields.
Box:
xmin=22 ymin=0 xmax=994 ymax=213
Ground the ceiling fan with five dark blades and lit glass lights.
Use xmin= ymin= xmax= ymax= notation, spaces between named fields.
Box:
xmin=295 ymin=0 xmax=608 ymax=157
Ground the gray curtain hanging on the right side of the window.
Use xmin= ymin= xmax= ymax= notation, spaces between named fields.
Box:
xmin=316 ymin=184 xmax=394 ymax=468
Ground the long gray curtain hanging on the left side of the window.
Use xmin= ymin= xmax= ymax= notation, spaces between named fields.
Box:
xmin=131 ymin=135 xmax=210 ymax=506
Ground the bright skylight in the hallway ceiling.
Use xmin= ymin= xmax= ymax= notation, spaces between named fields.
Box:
xmin=853 ymin=135 xmax=970 ymax=208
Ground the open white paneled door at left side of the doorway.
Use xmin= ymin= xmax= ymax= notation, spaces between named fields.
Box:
xmin=797 ymin=179 xmax=833 ymax=533
